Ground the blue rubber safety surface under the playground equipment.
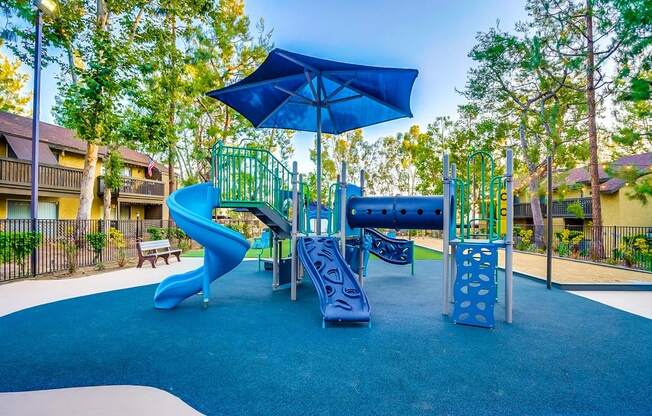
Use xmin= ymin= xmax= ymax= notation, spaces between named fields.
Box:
xmin=0 ymin=261 xmax=652 ymax=415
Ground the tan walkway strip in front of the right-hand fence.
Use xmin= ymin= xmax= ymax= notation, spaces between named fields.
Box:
xmin=415 ymin=238 xmax=652 ymax=283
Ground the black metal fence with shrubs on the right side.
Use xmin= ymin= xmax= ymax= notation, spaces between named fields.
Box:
xmin=514 ymin=225 xmax=652 ymax=272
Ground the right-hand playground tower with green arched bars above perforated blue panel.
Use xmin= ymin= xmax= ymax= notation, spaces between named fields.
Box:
xmin=442 ymin=149 xmax=514 ymax=327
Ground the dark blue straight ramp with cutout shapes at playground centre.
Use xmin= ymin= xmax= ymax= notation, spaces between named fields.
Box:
xmin=297 ymin=237 xmax=369 ymax=322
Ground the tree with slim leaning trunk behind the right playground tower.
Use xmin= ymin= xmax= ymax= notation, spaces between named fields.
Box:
xmin=464 ymin=24 xmax=568 ymax=247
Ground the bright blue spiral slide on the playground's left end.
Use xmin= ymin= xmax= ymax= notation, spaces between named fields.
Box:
xmin=154 ymin=183 xmax=249 ymax=309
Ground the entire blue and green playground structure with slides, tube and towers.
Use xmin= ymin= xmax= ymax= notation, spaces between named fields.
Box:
xmin=155 ymin=143 xmax=512 ymax=327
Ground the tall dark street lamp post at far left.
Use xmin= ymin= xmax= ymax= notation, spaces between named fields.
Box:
xmin=30 ymin=0 xmax=57 ymax=275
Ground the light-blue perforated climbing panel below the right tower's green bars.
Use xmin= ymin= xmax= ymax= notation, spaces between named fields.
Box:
xmin=453 ymin=243 xmax=498 ymax=328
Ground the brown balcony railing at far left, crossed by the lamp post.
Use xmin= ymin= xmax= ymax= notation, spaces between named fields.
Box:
xmin=0 ymin=158 xmax=82 ymax=193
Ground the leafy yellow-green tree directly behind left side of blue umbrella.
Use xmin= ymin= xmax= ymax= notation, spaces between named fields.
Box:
xmin=128 ymin=0 xmax=276 ymax=185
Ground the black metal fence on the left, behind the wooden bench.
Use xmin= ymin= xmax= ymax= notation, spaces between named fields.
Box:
xmin=0 ymin=220 xmax=178 ymax=282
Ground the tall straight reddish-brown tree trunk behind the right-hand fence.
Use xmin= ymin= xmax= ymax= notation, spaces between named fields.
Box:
xmin=586 ymin=0 xmax=604 ymax=259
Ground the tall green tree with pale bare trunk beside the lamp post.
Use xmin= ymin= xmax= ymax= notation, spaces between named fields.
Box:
xmin=7 ymin=0 xmax=142 ymax=219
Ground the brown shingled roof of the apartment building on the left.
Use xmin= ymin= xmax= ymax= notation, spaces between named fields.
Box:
xmin=0 ymin=111 xmax=167 ymax=171
